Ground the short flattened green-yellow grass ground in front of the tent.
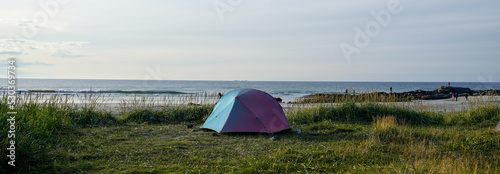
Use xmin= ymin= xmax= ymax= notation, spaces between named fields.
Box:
xmin=35 ymin=116 xmax=500 ymax=173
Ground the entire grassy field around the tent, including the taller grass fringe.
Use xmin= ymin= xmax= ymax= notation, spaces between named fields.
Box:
xmin=0 ymin=96 xmax=500 ymax=173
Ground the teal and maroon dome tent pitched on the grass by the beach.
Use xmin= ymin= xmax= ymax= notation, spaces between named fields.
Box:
xmin=201 ymin=89 xmax=290 ymax=133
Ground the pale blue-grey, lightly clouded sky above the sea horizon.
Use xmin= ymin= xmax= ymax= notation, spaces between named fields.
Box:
xmin=0 ymin=0 xmax=500 ymax=82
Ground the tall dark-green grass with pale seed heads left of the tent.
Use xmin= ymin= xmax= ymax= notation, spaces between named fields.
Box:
xmin=0 ymin=93 xmax=217 ymax=171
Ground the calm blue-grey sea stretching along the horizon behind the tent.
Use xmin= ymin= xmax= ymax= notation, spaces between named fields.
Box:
xmin=2 ymin=79 xmax=500 ymax=102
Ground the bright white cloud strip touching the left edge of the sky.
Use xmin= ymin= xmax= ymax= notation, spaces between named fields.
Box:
xmin=0 ymin=39 xmax=88 ymax=58
